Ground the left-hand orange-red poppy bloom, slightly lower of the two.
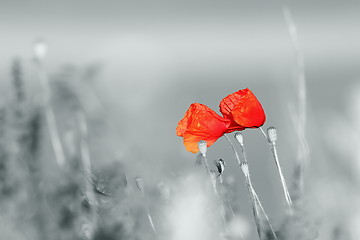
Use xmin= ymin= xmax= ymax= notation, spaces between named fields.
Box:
xmin=176 ymin=103 xmax=230 ymax=153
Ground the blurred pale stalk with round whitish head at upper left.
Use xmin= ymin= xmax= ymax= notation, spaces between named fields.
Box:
xmin=34 ymin=41 xmax=65 ymax=167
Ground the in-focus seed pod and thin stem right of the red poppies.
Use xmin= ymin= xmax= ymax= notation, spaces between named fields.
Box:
xmin=260 ymin=127 xmax=294 ymax=215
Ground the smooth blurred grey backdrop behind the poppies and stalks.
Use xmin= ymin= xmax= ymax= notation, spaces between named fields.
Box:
xmin=0 ymin=0 xmax=360 ymax=239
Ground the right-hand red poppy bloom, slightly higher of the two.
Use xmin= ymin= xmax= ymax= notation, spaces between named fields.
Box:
xmin=219 ymin=88 xmax=266 ymax=133
